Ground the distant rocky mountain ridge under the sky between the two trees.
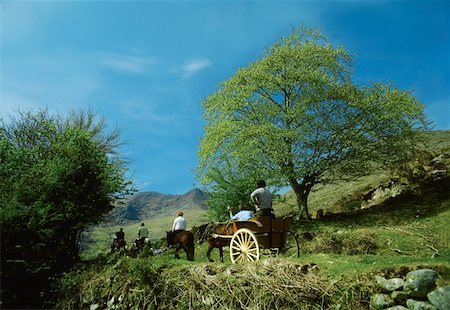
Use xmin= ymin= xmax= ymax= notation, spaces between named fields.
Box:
xmin=104 ymin=188 xmax=208 ymax=223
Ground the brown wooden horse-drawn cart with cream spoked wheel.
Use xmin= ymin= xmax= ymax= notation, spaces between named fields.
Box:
xmin=211 ymin=216 xmax=300 ymax=264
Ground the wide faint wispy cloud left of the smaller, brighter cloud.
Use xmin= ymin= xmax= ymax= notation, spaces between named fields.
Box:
xmin=101 ymin=55 xmax=157 ymax=73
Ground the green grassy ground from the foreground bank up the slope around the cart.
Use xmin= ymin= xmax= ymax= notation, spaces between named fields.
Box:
xmin=66 ymin=131 xmax=450 ymax=309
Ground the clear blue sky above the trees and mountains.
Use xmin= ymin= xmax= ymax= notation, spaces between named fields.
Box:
xmin=0 ymin=0 xmax=450 ymax=194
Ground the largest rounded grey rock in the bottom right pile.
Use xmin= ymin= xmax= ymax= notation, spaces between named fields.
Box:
xmin=403 ymin=269 xmax=437 ymax=298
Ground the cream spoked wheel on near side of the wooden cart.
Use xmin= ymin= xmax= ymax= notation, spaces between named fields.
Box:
xmin=230 ymin=228 xmax=259 ymax=264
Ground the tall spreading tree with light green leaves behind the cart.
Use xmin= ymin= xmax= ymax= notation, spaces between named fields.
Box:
xmin=197 ymin=27 xmax=427 ymax=218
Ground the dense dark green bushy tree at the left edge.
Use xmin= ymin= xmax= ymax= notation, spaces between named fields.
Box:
xmin=0 ymin=110 xmax=131 ymax=308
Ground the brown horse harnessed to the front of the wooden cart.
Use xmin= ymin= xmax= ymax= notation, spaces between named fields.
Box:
xmin=198 ymin=223 xmax=233 ymax=263
